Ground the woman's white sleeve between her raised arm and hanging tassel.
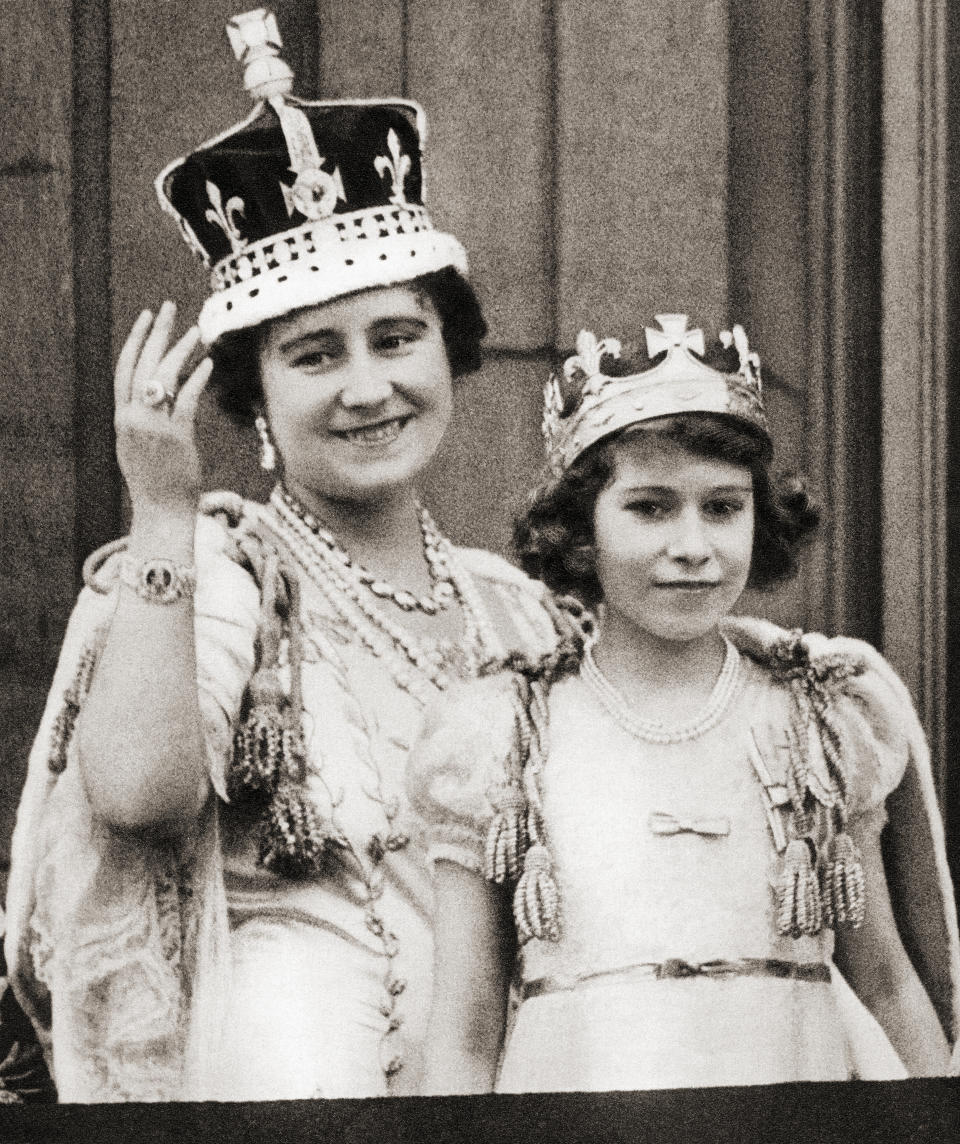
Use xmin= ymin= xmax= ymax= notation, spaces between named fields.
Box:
xmin=193 ymin=516 xmax=260 ymax=802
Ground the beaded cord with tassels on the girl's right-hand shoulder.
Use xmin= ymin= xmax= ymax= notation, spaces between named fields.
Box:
xmin=769 ymin=633 xmax=865 ymax=938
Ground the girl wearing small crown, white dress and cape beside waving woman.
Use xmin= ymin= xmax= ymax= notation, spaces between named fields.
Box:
xmin=410 ymin=315 xmax=958 ymax=1093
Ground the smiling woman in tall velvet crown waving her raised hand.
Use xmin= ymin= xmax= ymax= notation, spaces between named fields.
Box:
xmin=1 ymin=6 xmax=555 ymax=1101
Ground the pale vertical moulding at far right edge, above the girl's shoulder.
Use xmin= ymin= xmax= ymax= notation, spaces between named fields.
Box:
xmin=882 ymin=0 xmax=955 ymax=799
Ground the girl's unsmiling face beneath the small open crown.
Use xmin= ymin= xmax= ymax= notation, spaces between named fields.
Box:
xmin=594 ymin=432 xmax=754 ymax=641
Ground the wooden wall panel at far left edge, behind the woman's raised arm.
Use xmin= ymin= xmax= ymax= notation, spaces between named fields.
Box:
xmin=0 ymin=0 xmax=78 ymax=868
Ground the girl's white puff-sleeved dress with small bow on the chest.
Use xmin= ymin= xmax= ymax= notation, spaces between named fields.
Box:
xmin=410 ymin=627 xmax=957 ymax=1093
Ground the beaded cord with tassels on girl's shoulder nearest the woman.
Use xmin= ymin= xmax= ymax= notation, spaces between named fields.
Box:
xmin=484 ymin=613 xmax=584 ymax=944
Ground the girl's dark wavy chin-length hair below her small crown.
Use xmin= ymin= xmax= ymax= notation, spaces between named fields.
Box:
xmin=514 ymin=413 xmax=820 ymax=607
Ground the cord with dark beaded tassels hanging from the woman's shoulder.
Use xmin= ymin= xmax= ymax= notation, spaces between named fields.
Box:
xmin=205 ymin=499 xmax=341 ymax=879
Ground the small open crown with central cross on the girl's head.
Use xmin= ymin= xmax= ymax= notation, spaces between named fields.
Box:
xmin=544 ymin=313 xmax=768 ymax=476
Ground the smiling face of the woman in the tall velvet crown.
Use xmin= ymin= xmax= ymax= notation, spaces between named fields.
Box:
xmin=260 ymin=286 xmax=453 ymax=500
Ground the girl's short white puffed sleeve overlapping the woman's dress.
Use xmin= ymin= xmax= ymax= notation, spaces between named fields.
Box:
xmin=407 ymin=673 xmax=516 ymax=873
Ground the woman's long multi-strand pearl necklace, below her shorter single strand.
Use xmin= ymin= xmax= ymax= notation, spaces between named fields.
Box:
xmin=264 ymin=488 xmax=502 ymax=700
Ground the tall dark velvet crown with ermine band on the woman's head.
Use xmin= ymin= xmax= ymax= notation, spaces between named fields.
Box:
xmin=156 ymin=8 xmax=467 ymax=345
